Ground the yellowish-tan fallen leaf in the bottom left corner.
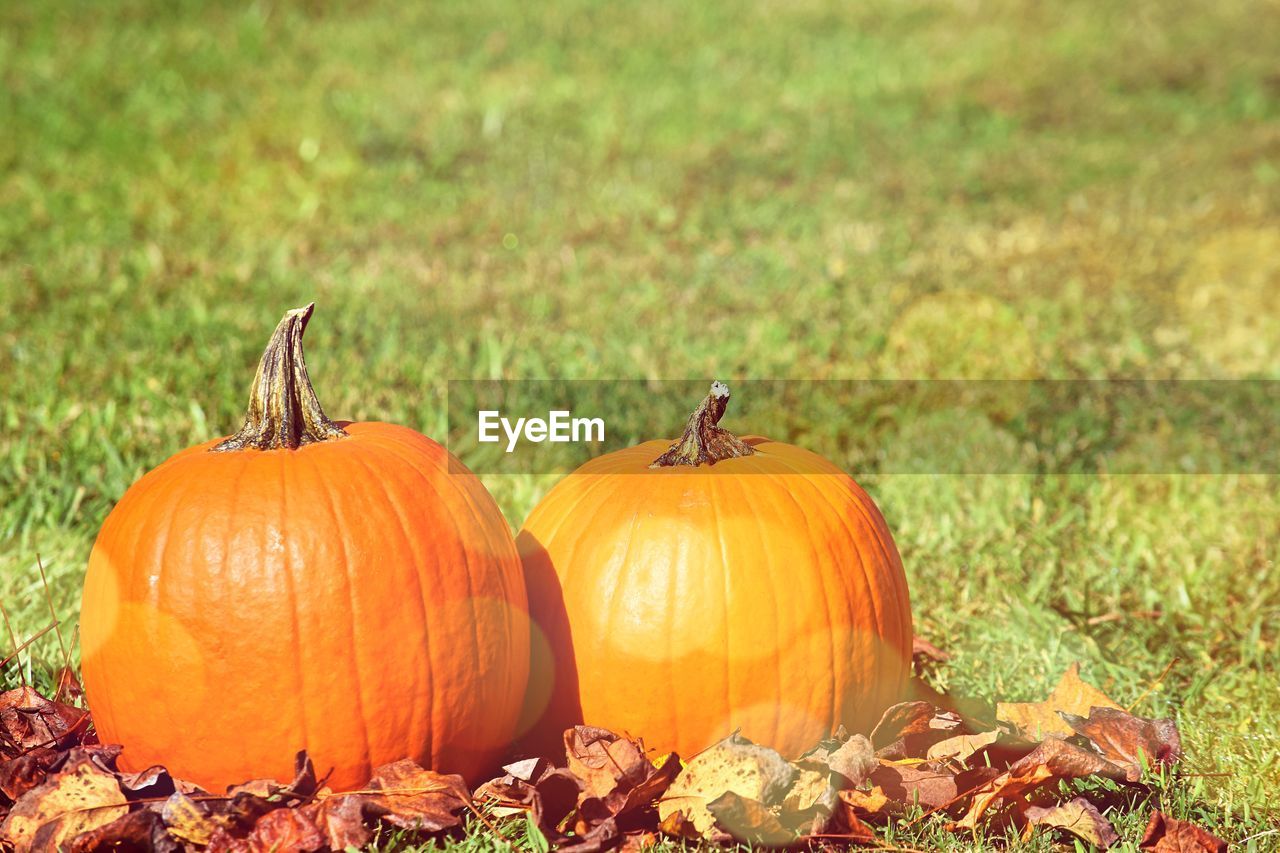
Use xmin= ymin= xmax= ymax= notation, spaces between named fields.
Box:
xmin=0 ymin=758 xmax=128 ymax=853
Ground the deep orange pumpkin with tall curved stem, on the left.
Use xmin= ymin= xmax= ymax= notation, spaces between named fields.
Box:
xmin=81 ymin=305 xmax=529 ymax=792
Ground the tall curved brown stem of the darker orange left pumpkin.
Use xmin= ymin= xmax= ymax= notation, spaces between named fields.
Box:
xmin=212 ymin=302 xmax=347 ymax=452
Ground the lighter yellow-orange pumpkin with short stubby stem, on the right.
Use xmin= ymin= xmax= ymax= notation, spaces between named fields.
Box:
xmin=516 ymin=383 xmax=911 ymax=757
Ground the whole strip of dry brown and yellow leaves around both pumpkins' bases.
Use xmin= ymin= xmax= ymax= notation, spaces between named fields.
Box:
xmin=0 ymin=667 xmax=1226 ymax=853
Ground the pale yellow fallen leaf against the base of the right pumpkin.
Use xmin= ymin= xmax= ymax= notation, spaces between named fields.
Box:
xmin=658 ymin=733 xmax=796 ymax=835
